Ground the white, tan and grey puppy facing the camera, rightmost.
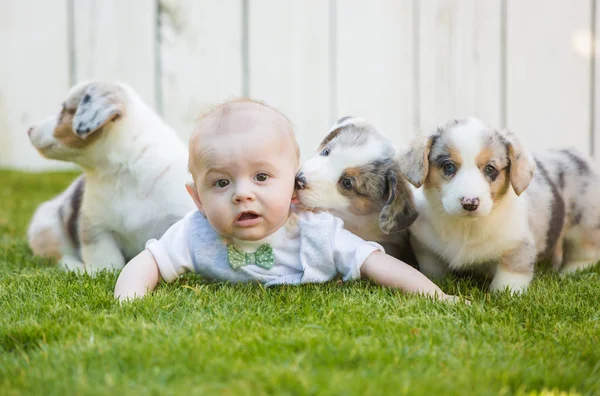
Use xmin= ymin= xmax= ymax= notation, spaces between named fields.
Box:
xmin=400 ymin=118 xmax=600 ymax=292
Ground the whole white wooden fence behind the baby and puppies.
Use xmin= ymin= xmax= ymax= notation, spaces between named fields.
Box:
xmin=0 ymin=0 xmax=600 ymax=169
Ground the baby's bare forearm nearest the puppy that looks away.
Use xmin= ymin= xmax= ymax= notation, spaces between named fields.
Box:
xmin=115 ymin=250 xmax=160 ymax=300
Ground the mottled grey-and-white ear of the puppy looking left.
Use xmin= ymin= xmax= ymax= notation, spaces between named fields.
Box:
xmin=72 ymin=83 xmax=125 ymax=139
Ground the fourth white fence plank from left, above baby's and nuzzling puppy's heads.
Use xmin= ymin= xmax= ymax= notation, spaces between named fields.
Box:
xmin=248 ymin=0 xmax=331 ymax=158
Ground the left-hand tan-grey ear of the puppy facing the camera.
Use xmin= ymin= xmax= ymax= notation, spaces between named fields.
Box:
xmin=398 ymin=135 xmax=435 ymax=188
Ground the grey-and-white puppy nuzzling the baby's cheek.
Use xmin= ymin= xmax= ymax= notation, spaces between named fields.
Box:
xmin=296 ymin=117 xmax=417 ymax=263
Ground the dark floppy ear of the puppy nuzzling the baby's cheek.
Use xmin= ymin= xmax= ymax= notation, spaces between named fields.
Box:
xmin=379 ymin=169 xmax=419 ymax=234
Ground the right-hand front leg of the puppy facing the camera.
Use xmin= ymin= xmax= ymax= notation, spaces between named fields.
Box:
xmin=490 ymin=241 xmax=536 ymax=293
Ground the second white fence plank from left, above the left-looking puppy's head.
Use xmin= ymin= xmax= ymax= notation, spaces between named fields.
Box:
xmin=73 ymin=0 xmax=157 ymax=106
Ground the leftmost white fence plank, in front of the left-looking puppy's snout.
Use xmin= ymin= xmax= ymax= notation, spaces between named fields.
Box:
xmin=0 ymin=0 xmax=69 ymax=170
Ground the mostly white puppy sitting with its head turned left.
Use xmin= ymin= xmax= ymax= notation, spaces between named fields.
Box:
xmin=28 ymin=82 xmax=194 ymax=273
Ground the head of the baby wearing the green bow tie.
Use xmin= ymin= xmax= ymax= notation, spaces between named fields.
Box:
xmin=187 ymin=99 xmax=300 ymax=241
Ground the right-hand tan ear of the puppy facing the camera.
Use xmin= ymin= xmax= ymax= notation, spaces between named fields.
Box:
xmin=500 ymin=129 xmax=535 ymax=195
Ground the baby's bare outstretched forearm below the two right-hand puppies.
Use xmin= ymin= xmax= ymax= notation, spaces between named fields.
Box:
xmin=360 ymin=251 xmax=456 ymax=300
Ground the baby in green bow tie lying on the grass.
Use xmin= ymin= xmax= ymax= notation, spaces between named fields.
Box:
xmin=115 ymin=100 xmax=462 ymax=300
